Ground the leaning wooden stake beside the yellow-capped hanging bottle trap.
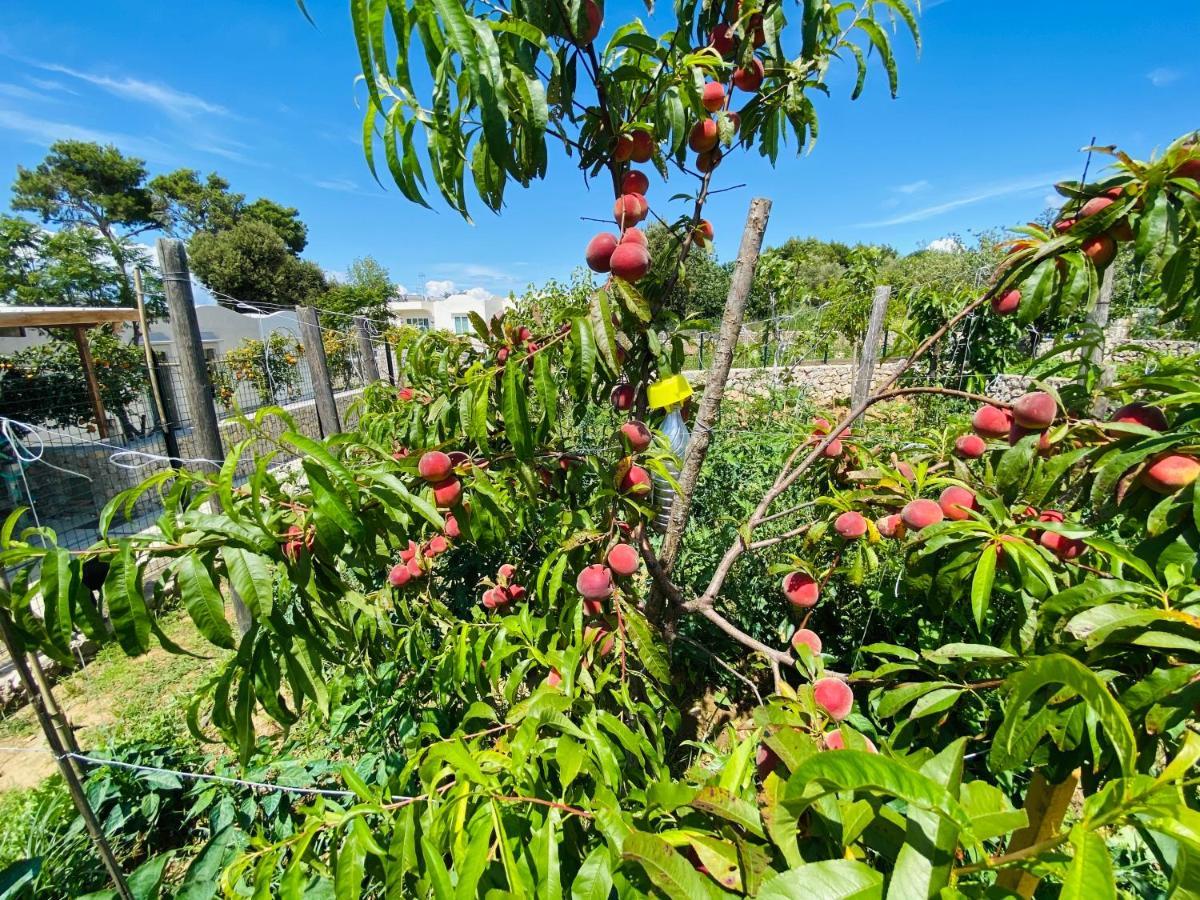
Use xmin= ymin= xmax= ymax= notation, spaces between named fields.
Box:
xmin=655 ymin=197 xmax=770 ymax=580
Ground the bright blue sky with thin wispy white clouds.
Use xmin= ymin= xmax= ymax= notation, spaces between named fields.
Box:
xmin=0 ymin=0 xmax=1200 ymax=293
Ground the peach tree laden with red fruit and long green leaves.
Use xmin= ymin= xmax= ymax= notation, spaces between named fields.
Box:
xmin=7 ymin=0 xmax=1200 ymax=898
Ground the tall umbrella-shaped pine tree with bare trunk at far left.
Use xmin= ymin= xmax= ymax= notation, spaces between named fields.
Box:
xmin=12 ymin=140 xmax=163 ymax=306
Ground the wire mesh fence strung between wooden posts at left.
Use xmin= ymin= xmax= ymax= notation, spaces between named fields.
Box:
xmin=0 ymin=314 xmax=390 ymax=550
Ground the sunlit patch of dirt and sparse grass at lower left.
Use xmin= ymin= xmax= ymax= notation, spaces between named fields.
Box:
xmin=0 ymin=613 xmax=224 ymax=791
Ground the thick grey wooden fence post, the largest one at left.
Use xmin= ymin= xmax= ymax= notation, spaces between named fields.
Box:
xmin=155 ymin=238 xmax=253 ymax=635
